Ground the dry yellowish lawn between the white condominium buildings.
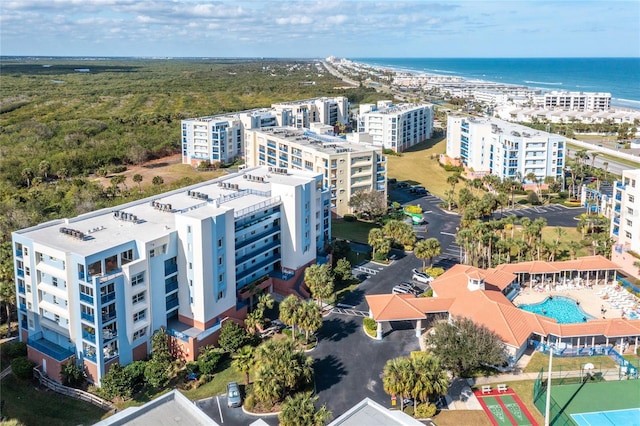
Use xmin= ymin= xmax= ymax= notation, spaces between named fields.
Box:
xmin=387 ymin=137 xmax=450 ymax=199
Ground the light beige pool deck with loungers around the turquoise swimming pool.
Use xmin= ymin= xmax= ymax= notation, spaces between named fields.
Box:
xmin=513 ymin=285 xmax=622 ymax=318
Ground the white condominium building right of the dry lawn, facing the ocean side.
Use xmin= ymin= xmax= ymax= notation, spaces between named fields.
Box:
xmin=447 ymin=115 xmax=566 ymax=181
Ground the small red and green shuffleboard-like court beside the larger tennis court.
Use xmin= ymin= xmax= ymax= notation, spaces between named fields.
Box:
xmin=474 ymin=389 xmax=536 ymax=426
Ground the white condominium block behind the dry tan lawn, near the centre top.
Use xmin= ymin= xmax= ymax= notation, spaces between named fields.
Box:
xmin=358 ymin=101 xmax=433 ymax=152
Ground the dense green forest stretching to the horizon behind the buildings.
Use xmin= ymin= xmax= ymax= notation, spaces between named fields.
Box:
xmin=0 ymin=58 xmax=380 ymax=242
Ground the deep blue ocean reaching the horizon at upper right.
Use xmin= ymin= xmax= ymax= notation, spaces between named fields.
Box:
xmin=350 ymin=58 xmax=640 ymax=109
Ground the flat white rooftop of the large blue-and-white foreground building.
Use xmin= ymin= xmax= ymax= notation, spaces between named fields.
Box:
xmin=16 ymin=166 xmax=316 ymax=255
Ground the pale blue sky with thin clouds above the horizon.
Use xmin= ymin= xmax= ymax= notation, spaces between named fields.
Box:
xmin=0 ymin=0 xmax=640 ymax=58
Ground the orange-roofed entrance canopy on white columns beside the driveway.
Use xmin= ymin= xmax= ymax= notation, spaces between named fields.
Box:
xmin=365 ymin=294 xmax=454 ymax=340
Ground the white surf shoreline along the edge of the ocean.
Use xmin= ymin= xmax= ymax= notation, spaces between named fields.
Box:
xmin=344 ymin=58 xmax=640 ymax=111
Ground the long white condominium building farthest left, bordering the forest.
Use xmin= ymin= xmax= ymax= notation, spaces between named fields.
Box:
xmin=181 ymin=96 xmax=349 ymax=166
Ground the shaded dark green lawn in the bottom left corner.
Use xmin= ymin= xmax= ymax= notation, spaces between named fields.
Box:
xmin=1 ymin=374 xmax=107 ymax=426
